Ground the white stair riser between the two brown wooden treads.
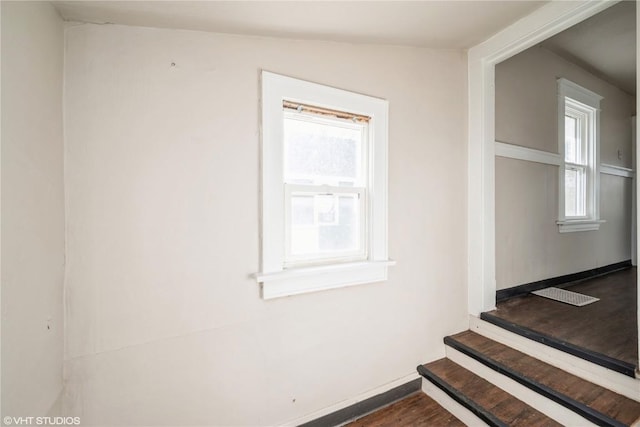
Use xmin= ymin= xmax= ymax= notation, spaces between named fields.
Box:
xmin=446 ymin=346 xmax=596 ymax=426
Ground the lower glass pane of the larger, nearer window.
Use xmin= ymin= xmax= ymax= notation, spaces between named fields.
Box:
xmin=291 ymin=194 xmax=361 ymax=258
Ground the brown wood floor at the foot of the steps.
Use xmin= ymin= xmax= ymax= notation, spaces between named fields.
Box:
xmin=347 ymin=392 xmax=464 ymax=427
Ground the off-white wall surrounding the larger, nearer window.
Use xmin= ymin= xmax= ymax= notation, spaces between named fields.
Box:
xmin=65 ymin=25 xmax=467 ymax=425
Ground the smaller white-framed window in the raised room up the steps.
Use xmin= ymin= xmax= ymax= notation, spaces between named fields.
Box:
xmin=558 ymin=79 xmax=603 ymax=233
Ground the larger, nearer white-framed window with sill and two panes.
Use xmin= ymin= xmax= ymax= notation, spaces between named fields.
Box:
xmin=256 ymin=71 xmax=393 ymax=299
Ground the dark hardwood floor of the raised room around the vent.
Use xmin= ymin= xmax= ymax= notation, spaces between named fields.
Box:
xmin=489 ymin=268 xmax=638 ymax=366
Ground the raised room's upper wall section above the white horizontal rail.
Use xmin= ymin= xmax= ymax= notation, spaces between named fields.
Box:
xmin=496 ymin=47 xmax=635 ymax=162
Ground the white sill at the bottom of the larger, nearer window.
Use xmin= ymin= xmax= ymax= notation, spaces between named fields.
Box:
xmin=255 ymin=260 xmax=396 ymax=299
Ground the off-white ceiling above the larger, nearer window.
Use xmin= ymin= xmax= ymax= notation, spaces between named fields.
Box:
xmin=52 ymin=0 xmax=546 ymax=49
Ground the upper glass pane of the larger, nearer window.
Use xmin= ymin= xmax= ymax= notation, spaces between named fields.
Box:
xmin=284 ymin=117 xmax=362 ymax=187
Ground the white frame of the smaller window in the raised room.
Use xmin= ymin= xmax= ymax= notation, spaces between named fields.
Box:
xmin=557 ymin=78 xmax=604 ymax=233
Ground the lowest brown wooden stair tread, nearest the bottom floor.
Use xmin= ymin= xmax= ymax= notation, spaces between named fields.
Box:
xmin=423 ymin=359 xmax=561 ymax=427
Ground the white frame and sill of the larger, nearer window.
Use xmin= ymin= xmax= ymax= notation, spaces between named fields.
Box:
xmin=255 ymin=71 xmax=394 ymax=299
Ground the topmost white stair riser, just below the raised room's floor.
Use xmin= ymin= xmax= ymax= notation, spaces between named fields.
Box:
xmin=469 ymin=316 xmax=640 ymax=402
